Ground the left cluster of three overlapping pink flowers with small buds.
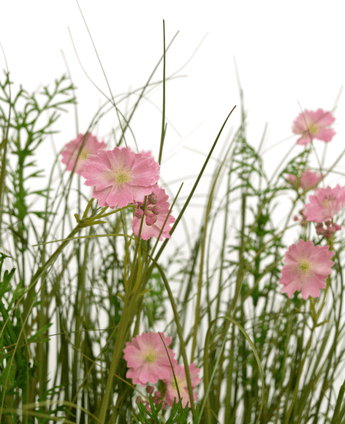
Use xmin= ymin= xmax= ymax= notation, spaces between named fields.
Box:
xmin=61 ymin=133 xmax=175 ymax=240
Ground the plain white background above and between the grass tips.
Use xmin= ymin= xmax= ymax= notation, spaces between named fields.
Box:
xmin=0 ymin=0 xmax=345 ymax=414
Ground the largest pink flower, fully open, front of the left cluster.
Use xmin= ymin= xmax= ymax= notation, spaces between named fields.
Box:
xmin=82 ymin=147 xmax=159 ymax=209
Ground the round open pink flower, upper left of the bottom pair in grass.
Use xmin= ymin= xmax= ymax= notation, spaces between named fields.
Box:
xmin=123 ymin=331 xmax=177 ymax=387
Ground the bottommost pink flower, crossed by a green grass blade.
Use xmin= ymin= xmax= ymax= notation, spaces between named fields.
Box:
xmin=163 ymin=362 xmax=201 ymax=408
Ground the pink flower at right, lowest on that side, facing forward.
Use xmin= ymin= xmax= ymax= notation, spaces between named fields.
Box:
xmin=279 ymin=239 xmax=334 ymax=300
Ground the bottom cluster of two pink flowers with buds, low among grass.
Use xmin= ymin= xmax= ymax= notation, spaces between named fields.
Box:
xmin=124 ymin=331 xmax=201 ymax=408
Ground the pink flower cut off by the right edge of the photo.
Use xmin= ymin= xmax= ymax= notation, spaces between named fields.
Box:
xmin=305 ymin=184 xmax=345 ymax=222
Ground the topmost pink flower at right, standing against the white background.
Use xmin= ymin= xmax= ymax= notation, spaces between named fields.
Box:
xmin=292 ymin=109 xmax=335 ymax=146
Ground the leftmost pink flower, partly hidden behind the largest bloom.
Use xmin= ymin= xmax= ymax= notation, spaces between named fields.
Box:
xmin=61 ymin=132 xmax=107 ymax=175
